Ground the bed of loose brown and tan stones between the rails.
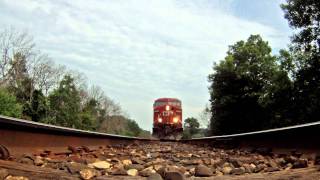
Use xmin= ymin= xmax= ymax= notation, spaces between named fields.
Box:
xmin=6 ymin=142 xmax=314 ymax=180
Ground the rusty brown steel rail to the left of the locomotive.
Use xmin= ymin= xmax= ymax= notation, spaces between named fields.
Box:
xmin=0 ymin=116 xmax=154 ymax=159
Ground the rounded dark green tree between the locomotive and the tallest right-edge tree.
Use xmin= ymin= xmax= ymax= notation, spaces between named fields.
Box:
xmin=209 ymin=35 xmax=288 ymax=134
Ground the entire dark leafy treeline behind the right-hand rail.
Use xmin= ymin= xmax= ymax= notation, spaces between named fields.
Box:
xmin=209 ymin=0 xmax=320 ymax=135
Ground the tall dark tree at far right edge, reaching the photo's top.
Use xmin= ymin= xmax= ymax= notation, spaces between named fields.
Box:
xmin=281 ymin=0 xmax=320 ymax=124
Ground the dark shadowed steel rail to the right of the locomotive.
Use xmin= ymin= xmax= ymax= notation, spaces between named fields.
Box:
xmin=182 ymin=121 xmax=320 ymax=153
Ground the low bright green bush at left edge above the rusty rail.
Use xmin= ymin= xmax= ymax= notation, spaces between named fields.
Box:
xmin=0 ymin=88 xmax=22 ymax=118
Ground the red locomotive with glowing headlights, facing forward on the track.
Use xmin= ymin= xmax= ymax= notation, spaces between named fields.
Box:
xmin=152 ymin=98 xmax=183 ymax=139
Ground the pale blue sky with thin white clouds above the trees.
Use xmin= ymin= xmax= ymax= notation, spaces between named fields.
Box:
xmin=0 ymin=0 xmax=292 ymax=130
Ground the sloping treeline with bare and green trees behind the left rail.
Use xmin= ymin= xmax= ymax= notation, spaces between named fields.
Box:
xmin=0 ymin=28 xmax=149 ymax=136
